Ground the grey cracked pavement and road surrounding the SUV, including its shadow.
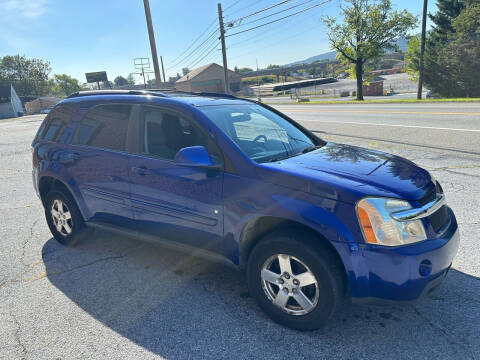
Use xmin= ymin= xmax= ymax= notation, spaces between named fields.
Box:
xmin=0 ymin=104 xmax=480 ymax=359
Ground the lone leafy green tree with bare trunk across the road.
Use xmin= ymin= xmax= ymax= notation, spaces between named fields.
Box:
xmin=324 ymin=0 xmax=417 ymax=100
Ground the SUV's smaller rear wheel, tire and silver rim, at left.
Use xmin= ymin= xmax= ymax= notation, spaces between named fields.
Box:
xmin=45 ymin=189 xmax=90 ymax=246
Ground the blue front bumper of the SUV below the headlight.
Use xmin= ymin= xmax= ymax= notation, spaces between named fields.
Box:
xmin=349 ymin=209 xmax=460 ymax=301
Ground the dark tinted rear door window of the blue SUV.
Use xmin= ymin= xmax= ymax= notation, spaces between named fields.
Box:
xmin=73 ymin=104 xmax=132 ymax=151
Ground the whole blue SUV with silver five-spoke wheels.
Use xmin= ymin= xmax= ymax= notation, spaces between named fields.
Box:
xmin=32 ymin=91 xmax=459 ymax=330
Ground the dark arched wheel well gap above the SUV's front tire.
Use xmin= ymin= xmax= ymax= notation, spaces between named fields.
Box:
xmin=239 ymin=216 xmax=347 ymax=280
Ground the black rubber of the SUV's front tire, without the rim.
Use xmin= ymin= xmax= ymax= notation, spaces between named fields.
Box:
xmin=247 ymin=236 xmax=340 ymax=330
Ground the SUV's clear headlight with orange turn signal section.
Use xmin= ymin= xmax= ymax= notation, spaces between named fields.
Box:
xmin=357 ymin=198 xmax=427 ymax=246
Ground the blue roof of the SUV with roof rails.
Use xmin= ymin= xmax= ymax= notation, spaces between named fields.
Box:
xmin=62 ymin=90 xmax=254 ymax=107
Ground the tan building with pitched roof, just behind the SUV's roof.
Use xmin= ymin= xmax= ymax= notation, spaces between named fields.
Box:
xmin=175 ymin=63 xmax=242 ymax=93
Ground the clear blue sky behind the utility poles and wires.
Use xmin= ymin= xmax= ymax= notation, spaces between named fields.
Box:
xmin=0 ymin=0 xmax=435 ymax=82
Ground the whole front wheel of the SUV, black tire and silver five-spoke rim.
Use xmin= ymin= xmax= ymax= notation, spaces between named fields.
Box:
xmin=247 ymin=229 xmax=345 ymax=331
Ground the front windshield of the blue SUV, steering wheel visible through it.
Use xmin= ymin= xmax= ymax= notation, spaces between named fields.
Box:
xmin=199 ymin=104 xmax=315 ymax=162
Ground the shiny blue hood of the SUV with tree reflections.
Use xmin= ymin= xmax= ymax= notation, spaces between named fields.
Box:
xmin=259 ymin=142 xmax=435 ymax=203
